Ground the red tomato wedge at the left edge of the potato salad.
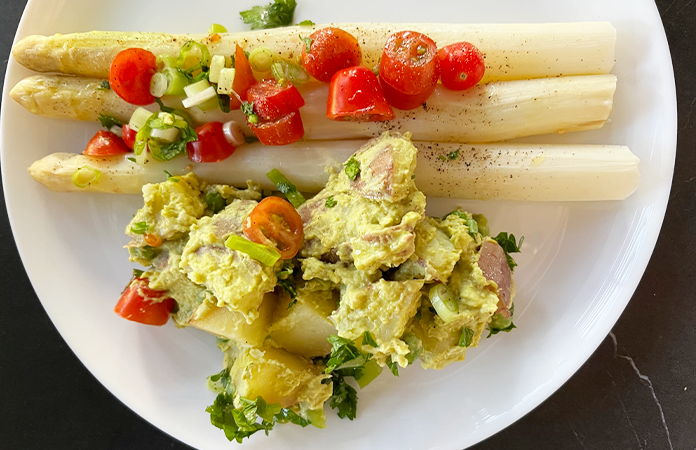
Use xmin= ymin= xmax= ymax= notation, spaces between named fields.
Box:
xmin=114 ymin=278 xmax=176 ymax=325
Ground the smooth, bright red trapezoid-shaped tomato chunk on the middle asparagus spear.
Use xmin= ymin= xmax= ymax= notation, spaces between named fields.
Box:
xmin=326 ymin=66 xmax=394 ymax=122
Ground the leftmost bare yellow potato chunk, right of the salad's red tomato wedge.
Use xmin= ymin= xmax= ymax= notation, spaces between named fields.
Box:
xmin=189 ymin=293 xmax=277 ymax=347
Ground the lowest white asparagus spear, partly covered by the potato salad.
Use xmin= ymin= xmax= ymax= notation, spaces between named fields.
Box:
xmin=29 ymin=141 xmax=640 ymax=201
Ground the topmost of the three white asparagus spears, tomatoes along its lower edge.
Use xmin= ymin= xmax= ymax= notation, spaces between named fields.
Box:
xmin=12 ymin=22 xmax=616 ymax=83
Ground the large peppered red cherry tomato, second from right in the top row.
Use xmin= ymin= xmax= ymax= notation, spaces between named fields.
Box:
xmin=379 ymin=31 xmax=440 ymax=96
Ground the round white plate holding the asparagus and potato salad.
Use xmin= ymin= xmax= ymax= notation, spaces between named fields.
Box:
xmin=2 ymin=0 xmax=676 ymax=449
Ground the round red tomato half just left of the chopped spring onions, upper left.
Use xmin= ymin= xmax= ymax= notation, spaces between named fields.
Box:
xmin=109 ymin=48 xmax=157 ymax=105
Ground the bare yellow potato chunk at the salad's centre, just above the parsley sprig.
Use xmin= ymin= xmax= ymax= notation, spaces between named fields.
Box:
xmin=270 ymin=289 xmax=336 ymax=358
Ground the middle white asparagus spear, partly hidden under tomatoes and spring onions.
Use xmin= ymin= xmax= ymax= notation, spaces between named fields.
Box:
xmin=10 ymin=74 xmax=616 ymax=142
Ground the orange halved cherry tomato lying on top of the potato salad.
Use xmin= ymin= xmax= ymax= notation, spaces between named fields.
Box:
xmin=242 ymin=197 xmax=304 ymax=259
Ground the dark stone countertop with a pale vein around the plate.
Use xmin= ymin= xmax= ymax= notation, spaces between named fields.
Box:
xmin=0 ymin=0 xmax=696 ymax=450
